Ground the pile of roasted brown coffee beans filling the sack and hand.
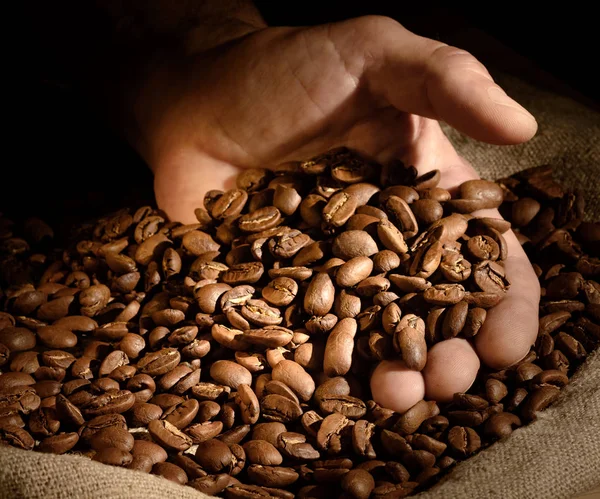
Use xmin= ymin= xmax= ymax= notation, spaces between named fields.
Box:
xmin=0 ymin=149 xmax=600 ymax=499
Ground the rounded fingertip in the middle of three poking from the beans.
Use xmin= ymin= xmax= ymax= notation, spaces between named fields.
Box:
xmin=423 ymin=338 xmax=480 ymax=402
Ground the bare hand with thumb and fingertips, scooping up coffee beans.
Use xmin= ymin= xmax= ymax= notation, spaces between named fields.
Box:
xmin=124 ymin=17 xmax=540 ymax=412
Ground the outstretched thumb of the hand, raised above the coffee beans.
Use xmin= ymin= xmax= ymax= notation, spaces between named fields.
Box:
xmin=338 ymin=17 xmax=537 ymax=144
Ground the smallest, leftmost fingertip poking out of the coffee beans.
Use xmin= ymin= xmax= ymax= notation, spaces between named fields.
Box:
xmin=371 ymin=360 xmax=425 ymax=413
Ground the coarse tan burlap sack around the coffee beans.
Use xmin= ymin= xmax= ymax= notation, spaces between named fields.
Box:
xmin=0 ymin=76 xmax=600 ymax=499
